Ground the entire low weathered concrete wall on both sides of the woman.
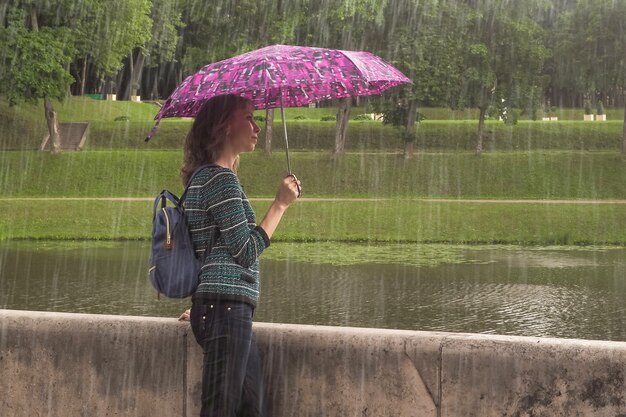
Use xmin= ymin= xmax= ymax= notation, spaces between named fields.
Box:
xmin=0 ymin=310 xmax=626 ymax=417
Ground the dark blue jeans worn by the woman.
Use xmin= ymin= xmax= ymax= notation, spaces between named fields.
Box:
xmin=190 ymin=301 xmax=263 ymax=417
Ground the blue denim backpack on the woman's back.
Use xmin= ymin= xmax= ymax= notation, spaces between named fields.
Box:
xmin=148 ymin=165 xmax=211 ymax=298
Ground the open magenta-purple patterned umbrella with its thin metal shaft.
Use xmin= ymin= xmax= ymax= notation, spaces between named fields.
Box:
xmin=146 ymin=45 xmax=411 ymax=173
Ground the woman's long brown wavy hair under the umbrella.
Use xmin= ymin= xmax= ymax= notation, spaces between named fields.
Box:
xmin=180 ymin=94 xmax=250 ymax=186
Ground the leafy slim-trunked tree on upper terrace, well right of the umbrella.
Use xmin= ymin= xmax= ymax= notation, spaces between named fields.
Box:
xmin=459 ymin=0 xmax=550 ymax=154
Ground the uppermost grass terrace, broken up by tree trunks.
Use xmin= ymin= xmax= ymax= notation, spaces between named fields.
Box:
xmin=0 ymin=98 xmax=623 ymax=151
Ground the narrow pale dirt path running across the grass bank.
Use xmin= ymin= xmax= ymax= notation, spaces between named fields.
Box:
xmin=0 ymin=197 xmax=626 ymax=204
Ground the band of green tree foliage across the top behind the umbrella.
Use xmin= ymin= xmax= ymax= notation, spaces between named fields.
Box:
xmin=0 ymin=0 xmax=626 ymax=153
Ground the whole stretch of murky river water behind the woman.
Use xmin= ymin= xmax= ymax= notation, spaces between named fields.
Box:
xmin=0 ymin=241 xmax=626 ymax=341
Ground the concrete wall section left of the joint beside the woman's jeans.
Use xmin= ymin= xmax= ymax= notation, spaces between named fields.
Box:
xmin=0 ymin=310 xmax=186 ymax=417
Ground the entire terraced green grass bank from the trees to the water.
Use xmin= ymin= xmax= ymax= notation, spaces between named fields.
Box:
xmin=0 ymin=99 xmax=626 ymax=245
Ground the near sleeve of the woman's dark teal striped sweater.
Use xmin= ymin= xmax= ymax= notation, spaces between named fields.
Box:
xmin=203 ymin=170 xmax=269 ymax=268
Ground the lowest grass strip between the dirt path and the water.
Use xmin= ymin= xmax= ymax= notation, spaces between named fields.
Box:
xmin=0 ymin=200 xmax=626 ymax=245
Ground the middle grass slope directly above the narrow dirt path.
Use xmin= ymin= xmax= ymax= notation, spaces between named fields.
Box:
xmin=0 ymin=150 xmax=626 ymax=199
